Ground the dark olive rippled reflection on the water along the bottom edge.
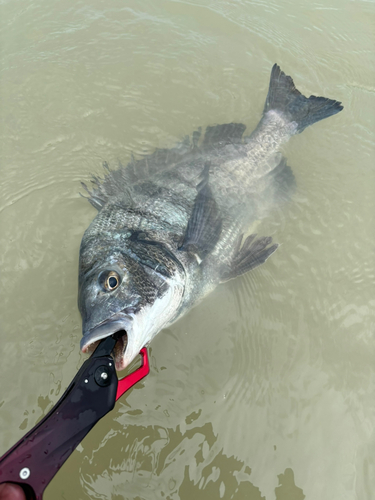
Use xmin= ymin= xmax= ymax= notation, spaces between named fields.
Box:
xmin=76 ymin=420 xmax=305 ymax=500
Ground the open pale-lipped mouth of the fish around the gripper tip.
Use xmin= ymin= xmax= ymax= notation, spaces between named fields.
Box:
xmin=80 ymin=314 xmax=133 ymax=371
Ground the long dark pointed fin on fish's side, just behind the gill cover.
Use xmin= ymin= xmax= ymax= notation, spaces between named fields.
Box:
xmin=179 ymin=162 xmax=222 ymax=259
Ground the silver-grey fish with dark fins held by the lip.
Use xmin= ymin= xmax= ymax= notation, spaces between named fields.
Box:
xmin=78 ymin=64 xmax=343 ymax=370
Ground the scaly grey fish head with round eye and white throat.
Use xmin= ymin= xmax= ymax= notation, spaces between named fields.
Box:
xmin=78 ymin=240 xmax=185 ymax=370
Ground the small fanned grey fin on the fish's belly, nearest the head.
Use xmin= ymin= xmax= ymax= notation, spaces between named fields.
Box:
xmin=221 ymin=234 xmax=278 ymax=282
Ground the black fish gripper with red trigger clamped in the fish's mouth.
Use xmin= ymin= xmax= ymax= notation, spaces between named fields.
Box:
xmin=0 ymin=330 xmax=150 ymax=500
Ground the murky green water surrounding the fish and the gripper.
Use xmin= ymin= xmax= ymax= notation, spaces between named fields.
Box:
xmin=0 ymin=0 xmax=375 ymax=500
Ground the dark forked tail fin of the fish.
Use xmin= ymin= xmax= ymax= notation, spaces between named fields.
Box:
xmin=263 ymin=64 xmax=343 ymax=133
